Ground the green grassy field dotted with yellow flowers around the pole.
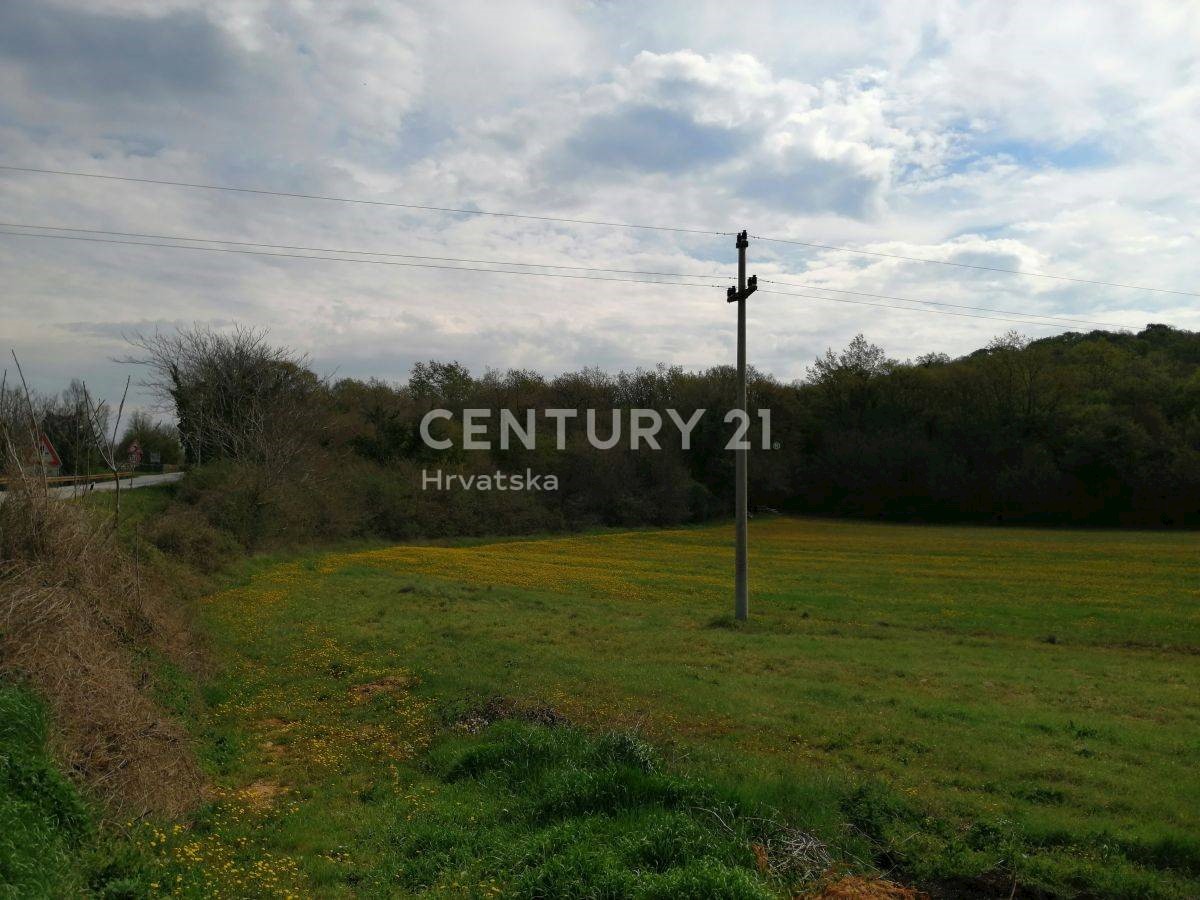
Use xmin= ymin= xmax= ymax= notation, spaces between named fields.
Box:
xmin=11 ymin=518 xmax=1200 ymax=898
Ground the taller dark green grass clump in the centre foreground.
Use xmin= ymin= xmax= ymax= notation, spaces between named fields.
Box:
xmin=383 ymin=722 xmax=774 ymax=898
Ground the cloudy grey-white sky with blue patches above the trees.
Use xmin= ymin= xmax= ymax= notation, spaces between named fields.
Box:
xmin=0 ymin=0 xmax=1200 ymax=408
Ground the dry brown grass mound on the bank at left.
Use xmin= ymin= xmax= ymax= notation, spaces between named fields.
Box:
xmin=0 ymin=479 xmax=203 ymax=816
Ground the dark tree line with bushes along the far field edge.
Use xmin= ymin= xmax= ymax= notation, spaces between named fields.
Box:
xmin=4 ymin=325 xmax=1200 ymax=544
